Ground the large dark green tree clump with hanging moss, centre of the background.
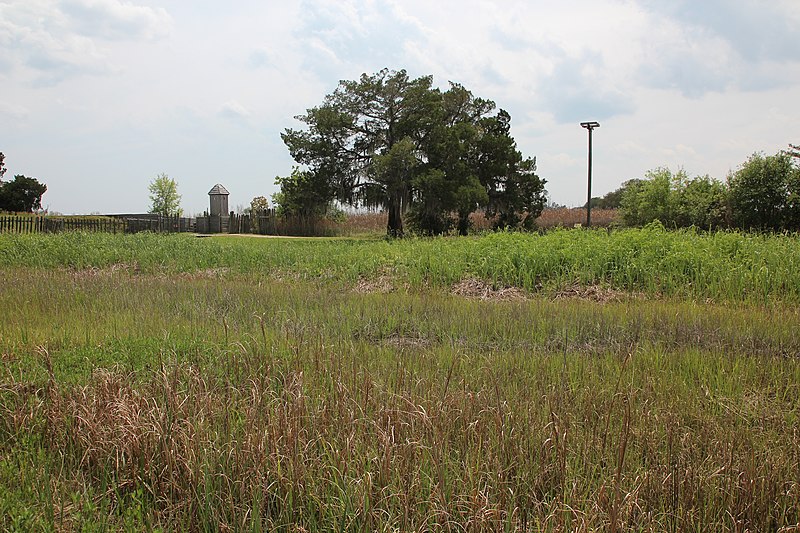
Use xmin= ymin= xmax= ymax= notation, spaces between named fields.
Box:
xmin=276 ymin=69 xmax=546 ymax=236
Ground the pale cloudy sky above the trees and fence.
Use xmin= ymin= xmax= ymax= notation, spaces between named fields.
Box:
xmin=0 ymin=0 xmax=800 ymax=215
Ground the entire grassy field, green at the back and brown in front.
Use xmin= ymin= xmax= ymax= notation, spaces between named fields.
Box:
xmin=0 ymin=228 xmax=800 ymax=531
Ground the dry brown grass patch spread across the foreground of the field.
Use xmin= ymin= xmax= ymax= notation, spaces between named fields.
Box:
xmin=2 ymin=337 xmax=800 ymax=531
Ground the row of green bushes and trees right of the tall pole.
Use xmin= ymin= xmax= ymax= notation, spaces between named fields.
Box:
xmin=592 ymin=150 xmax=800 ymax=231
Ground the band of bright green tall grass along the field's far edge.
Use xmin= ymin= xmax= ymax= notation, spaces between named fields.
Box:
xmin=0 ymin=226 xmax=800 ymax=302
